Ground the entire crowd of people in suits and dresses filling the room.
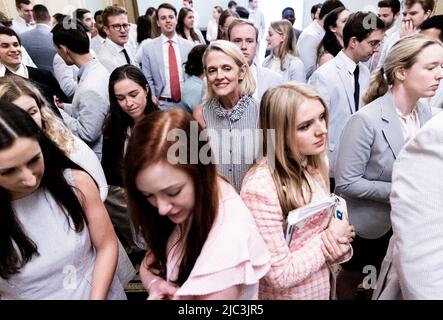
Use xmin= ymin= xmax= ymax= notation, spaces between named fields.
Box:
xmin=0 ymin=0 xmax=443 ymax=300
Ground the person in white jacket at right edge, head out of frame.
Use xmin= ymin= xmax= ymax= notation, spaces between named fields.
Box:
xmin=373 ymin=113 xmax=443 ymax=300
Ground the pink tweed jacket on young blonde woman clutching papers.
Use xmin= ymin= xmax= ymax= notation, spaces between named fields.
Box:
xmin=240 ymin=163 xmax=331 ymax=300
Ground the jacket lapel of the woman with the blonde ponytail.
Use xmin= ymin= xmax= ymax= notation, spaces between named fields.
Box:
xmin=379 ymin=91 xmax=405 ymax=158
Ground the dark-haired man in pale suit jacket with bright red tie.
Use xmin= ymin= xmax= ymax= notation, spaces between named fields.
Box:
xmin=142 ymin=3 xmax=194 ymax=109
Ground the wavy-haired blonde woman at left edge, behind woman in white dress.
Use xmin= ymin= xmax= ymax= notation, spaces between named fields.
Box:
xmin=0 ymin=76 xmax=108 ymax=201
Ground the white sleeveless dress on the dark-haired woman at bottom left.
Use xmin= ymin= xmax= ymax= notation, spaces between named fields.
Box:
xmin=0 ymin=170 xmax=126 ymax=300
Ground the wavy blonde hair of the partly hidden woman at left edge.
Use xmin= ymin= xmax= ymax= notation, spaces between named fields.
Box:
xmin=0 ymin=76 xmax=74 ymax=156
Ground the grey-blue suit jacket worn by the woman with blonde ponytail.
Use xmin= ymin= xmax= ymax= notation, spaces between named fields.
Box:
xmin=335 ymin=91 xmax=432 ymax=239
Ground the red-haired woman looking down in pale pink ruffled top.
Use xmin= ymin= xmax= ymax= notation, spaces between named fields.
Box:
xmin=125 ymin=109 xmax=270 ymax=299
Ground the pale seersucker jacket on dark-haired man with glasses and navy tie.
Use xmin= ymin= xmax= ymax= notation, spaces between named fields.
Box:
xmin=308 ymin=53 xmax=370 ymax=177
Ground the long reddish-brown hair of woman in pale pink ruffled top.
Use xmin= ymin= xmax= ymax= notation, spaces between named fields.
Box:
xmin=124 ymin=109 xmax=219 ymax=285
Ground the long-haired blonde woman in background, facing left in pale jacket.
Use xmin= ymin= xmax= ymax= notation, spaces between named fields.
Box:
xmin=263 ymin=19 xmax=306 ymax=83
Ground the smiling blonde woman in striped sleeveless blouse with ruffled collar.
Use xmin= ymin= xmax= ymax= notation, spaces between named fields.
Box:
xmin=194 ymin=40 xmax=260 ymax=191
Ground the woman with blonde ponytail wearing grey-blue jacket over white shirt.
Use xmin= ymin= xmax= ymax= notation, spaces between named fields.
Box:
xmin=335 ymin=35 xmax=443 ymax=299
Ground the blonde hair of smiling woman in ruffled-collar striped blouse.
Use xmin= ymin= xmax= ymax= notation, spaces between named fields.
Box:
xmin=203 ymin=40 xmax=256 ymax=101
